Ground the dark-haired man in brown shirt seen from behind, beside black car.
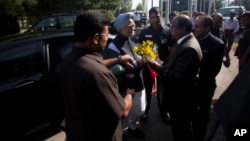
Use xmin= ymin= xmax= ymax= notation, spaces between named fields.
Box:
xmin=61 ymin=10 xmax=134 ymax=141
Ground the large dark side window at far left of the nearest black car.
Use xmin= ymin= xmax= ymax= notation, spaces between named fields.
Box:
xmin=0 ymin=43 xmax=42 ymax=83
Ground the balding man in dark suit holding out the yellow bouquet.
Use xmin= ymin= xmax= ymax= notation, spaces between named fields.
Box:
xmin=149 ymin=15 xmax=202 ymax=141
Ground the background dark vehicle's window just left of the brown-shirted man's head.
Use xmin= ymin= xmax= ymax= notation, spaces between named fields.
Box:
xmin=59 ymin=15 xmax=76 ymax=28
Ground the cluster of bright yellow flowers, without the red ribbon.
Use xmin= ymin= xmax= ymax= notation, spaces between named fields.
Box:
xmin=133 ymin=40 xmax=157 ymax=60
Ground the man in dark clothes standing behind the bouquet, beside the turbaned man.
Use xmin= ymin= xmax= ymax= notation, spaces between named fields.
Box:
xmin=138 ymin=7 xmax=175 ymax=123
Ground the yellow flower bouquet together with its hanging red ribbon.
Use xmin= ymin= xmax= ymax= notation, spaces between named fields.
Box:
xmin=133 ymin=40 xmax=158 ymax=96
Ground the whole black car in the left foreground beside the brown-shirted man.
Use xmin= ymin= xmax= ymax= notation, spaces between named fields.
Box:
xmin=0 ymin=30 xmax=74 ymax=140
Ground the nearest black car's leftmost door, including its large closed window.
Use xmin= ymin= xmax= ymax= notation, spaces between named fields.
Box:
xmin=0 ymin=41 xmax=44 ymax=138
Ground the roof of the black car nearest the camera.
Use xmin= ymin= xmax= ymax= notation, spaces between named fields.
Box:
xmin=0 ymin=30 xmax=74 ymax=50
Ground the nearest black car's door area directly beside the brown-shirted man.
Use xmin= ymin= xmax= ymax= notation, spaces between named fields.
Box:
xmin=43 ymin=35 xmax=74 ymax=126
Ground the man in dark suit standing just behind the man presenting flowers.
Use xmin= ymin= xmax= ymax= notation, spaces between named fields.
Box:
xmin=193 ymin=15 xmax=225 ymax=141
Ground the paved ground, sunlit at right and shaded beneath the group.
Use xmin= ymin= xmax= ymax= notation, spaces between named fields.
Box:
xmin=46 ymin=34 xmax=238 ymax=141
